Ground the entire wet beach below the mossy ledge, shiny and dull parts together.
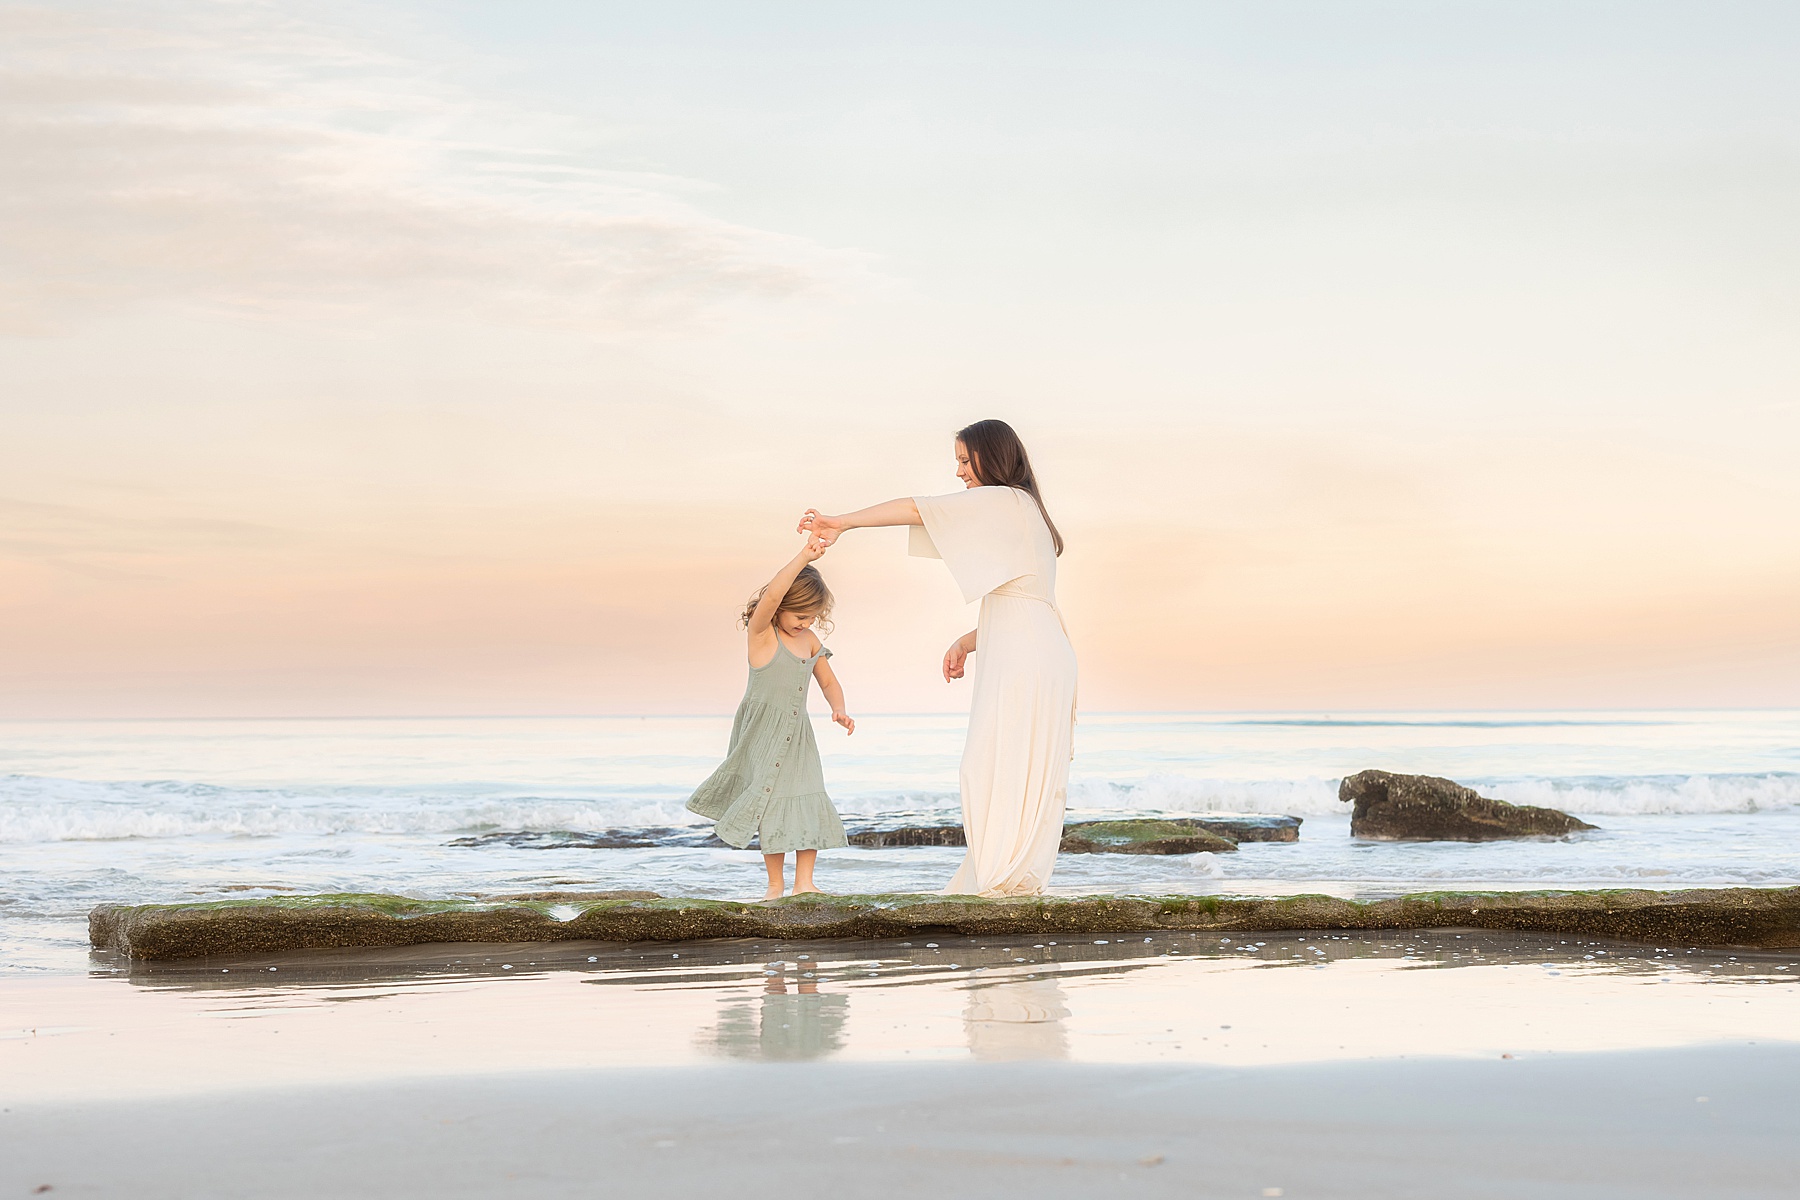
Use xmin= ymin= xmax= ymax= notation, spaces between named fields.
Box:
xmin=0 ymin=930 xmax=1800 ymax=1198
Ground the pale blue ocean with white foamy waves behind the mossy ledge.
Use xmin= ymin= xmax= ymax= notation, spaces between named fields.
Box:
xmin=0 ymin=711 xmax=1800 ymax=973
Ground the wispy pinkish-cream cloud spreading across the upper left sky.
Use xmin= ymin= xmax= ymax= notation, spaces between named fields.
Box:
xmin=0 ymin=2 xmax=853 ymax=333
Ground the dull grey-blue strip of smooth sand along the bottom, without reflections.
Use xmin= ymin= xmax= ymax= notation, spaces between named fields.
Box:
xmin=0 ymin=1047 xmax=1800 ymax=1200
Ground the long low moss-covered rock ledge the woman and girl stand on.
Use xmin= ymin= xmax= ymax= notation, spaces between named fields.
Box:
xmin=88 ymin=887 xmax=1800 ymax=959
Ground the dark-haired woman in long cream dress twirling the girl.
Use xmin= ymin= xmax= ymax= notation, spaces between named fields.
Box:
xmin=799 ymin=421 xmax=1075 ymax=896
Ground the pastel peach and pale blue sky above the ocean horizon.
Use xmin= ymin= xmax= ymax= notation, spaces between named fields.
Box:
xmin=0 ymin=0 xmax=1800 ymax=716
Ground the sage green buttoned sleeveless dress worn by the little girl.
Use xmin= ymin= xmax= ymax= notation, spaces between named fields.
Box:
xmin=688 ymin=637 xmax=848 ymax=855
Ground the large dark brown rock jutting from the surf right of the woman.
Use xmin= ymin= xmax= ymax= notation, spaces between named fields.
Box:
xmin=1337 ymin=770 xmax=1595 ymax=842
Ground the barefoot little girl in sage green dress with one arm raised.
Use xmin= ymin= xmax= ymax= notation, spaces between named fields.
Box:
xmin=688 ymin=538 xmax=857 ymax=900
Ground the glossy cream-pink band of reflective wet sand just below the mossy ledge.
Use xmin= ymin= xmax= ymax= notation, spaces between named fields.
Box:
xmin=0 ymin=930 xmax=1800 ymax=1108
